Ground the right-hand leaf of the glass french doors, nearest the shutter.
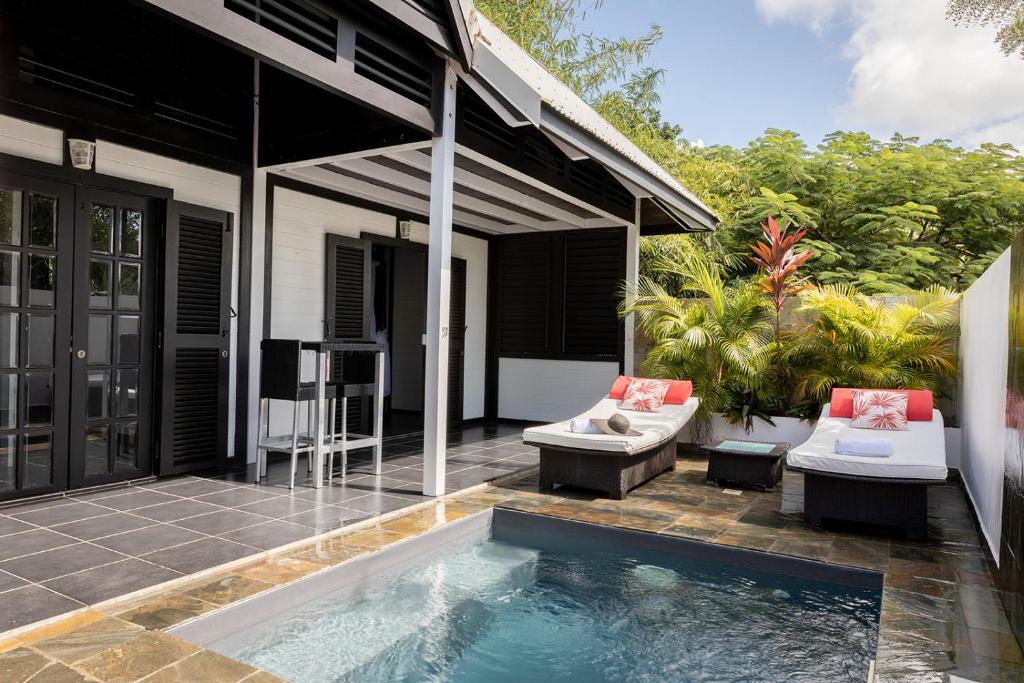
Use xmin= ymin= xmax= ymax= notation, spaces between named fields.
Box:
xmin=69 ymin=188 xmax=156 ymax=487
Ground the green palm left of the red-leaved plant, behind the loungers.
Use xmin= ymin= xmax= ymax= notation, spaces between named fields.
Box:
xmin=620 ymin=252 xmax=772 ymax=432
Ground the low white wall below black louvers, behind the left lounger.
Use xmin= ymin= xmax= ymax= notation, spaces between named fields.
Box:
xmin=498 ymin=358 xmax=618 ymax=422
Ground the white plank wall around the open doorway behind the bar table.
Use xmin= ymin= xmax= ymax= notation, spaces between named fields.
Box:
xmin=270 ymin=187 xmax=487 ymax=431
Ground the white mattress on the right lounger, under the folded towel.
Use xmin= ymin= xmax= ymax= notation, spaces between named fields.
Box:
xmin=786 ymin=403 xmax=947 ymax=479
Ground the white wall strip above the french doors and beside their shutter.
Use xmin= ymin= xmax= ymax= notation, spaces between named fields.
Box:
xmin=95 ymin=139 xmax=242 ymax=457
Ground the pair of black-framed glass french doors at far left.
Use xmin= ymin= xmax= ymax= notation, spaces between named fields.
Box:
xmin=0 ymin=173 xmax=156 ymax=500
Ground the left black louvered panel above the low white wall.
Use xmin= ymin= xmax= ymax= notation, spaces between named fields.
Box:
xmin=498 ymin=234 xmax=550 ymax=354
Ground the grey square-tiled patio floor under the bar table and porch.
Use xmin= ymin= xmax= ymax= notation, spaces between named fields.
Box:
xmin=0 ymin=425 xmax=537 ymax=634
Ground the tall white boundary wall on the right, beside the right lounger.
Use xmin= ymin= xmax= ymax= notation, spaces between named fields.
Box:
xmin=959 ymin=249 xmax=1010 ymax=562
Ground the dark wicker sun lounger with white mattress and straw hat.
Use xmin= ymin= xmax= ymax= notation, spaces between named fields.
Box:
xmin=522 ymin=396 xmax=700 ymax=500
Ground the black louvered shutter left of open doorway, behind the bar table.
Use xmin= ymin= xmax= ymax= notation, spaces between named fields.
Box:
xmin=324 ymin=234 xmax=377 ymax=434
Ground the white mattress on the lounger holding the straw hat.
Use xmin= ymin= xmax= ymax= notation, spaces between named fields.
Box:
xmin=522 ymin=396 xmax=700 ymax=455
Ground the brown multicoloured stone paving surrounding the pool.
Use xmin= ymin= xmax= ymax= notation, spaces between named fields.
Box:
xmin=0 ymin=459 xmax=1024 ymax=682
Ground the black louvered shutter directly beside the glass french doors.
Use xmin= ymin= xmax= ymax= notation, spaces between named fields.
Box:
xmin=159 ymin=202 xmax=231 ymax=475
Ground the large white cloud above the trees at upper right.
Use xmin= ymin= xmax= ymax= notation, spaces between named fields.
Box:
xmin=757 ymin=0 xmax=1024 ymax=150
